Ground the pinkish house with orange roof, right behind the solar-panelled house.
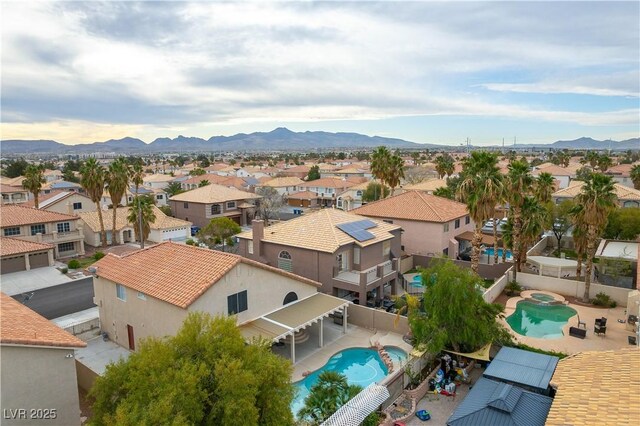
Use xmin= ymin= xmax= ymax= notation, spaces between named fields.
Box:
xmin=353 ymin=191 xmax=474 ymax=259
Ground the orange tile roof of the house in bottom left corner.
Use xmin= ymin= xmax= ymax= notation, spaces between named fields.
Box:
xmin=0 ymin=293 xmax=87 ymax=348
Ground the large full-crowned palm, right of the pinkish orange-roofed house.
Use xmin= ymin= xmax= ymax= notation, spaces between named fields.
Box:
xmin=456 ymin=151 xmax=502 ymax=273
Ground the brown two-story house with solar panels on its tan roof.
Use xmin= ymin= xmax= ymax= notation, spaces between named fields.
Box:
xmin=238 ymin=209 xmax=401 ymax=305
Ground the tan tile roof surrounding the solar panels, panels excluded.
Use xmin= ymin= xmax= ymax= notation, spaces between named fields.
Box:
xmin=237 ymin=209 xmax=400 ymax=253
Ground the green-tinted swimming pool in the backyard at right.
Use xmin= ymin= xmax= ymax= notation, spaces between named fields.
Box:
xmin=507 ymin=300 xmax=577 ymax=339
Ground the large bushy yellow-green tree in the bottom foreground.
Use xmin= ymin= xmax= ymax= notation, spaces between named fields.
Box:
xmin=90 ymin=313 xmax=294 ymax=426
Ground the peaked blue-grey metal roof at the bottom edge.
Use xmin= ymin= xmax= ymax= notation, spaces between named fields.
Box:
xmin=447 ymin=377 xmax=553 ymax=426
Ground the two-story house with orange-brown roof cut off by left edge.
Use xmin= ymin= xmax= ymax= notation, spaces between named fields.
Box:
xmin=0 ymin=204 xmax=84 ymax=259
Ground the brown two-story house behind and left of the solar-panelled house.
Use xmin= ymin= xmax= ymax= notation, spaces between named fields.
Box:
xmin=169 ymin=184 xmax=261 ymax=227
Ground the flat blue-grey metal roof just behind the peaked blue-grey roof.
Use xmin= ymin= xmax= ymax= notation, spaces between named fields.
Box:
xmin=483 ymin=347 xmax=560 ymax=392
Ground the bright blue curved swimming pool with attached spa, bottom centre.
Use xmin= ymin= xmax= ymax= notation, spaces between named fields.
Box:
xmin=291 ymin=346 xmax=407 ymax=415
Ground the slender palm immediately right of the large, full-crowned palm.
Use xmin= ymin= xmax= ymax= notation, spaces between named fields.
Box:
xmin=507 ymin=160 xmax=533 ymax=281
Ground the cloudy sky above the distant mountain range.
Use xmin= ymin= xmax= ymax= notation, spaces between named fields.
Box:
xmin=0 ymin=1 xmax=640 ymax=145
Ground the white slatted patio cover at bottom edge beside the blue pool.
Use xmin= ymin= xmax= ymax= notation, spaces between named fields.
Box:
xmin=322 ymin=383 xmax=390 ymax=426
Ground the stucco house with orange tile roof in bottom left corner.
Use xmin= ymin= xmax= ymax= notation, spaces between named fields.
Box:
xmin=0 ymin=293 xmax=87 ymax=426
